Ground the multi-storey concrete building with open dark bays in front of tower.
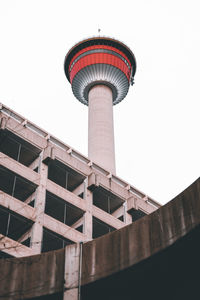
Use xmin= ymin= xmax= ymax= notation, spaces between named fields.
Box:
xmin=0 ymin=104 xmax=160 ymax=257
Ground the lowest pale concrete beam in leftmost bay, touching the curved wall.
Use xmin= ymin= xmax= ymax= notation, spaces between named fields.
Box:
xmin=0 ymin=234 xmax=36 ymax=257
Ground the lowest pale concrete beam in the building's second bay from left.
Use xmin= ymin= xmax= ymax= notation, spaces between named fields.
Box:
xmin=44 ymin=214 xmax=87 ymax=243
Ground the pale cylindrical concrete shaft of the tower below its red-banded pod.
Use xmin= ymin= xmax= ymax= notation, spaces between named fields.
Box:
xmin=88 ymin=85 xmax=115 ymax=174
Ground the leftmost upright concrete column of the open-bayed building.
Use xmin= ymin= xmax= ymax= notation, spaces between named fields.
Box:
xmin=31 ymin=154 xmax=48 ymax=254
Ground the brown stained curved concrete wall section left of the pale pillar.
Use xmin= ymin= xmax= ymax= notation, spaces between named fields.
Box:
xmin=0 ymin=249 xmax=64 ymax=300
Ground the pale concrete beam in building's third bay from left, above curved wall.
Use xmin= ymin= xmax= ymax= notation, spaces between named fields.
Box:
xmin=92 ymin=205 xmax=126 ymax=229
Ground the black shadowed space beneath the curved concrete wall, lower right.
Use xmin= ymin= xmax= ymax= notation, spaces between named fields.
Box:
xmin=81 ymin=226 xmax=200 ymax=300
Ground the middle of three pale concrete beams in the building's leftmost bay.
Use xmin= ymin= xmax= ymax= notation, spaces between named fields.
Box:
xmin=0 ymin=190 xmax=35 ymax=222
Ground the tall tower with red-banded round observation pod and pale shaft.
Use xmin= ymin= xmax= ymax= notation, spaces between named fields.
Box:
xmin=64 ymin=37 xmax=136 ymax=174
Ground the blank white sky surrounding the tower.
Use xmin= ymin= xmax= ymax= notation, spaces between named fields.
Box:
xmin=0 ymin=0 xmax=200 ymax=204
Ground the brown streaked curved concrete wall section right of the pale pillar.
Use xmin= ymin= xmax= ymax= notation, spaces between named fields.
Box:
xmin=82 ymin=179 xmax=200 ymax=285
